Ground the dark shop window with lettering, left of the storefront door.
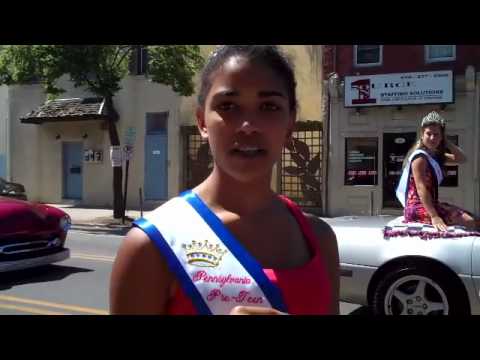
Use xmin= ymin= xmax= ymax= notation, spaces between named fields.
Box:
xmin=345 ymin=138 xmax=378 ymax=185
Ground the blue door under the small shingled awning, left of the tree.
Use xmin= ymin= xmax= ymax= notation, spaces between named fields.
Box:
xmin=63 ymin=142 xmax=83 ymax=199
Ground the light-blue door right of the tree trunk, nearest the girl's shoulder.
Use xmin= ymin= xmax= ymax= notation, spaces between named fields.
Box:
xmin=145 ymin=134 xmax=168 ymax=200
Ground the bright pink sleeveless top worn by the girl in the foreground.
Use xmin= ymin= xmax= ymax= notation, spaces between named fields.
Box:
xmin=167 ymin=196 xmax=332 ymax=315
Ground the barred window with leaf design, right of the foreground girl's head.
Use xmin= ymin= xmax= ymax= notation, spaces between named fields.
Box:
xmin=279 ymin=121 xmax=323 ymax=209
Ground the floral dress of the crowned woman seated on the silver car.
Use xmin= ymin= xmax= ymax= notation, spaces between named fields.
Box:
xmin=404 ymin=155 xmax=468 ymax=225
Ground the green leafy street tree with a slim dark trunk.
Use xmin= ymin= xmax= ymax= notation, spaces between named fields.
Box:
xmin=0 ymin=45 xmax=203 ymax=218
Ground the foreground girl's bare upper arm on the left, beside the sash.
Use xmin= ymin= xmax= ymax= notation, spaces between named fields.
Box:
xmin=110 ymin=228 xmax=174 ymax=315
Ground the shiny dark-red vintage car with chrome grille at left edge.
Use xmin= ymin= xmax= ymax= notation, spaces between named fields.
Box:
xmin=0 ymin=196 xmax=71 ymax=272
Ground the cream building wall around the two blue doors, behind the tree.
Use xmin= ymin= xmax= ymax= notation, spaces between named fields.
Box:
xmin=8 ymin=76 xmax=181 ymax=209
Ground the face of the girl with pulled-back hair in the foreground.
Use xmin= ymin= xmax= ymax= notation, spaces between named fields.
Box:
xmin=197 ymin=56 xmax=296 ymax=181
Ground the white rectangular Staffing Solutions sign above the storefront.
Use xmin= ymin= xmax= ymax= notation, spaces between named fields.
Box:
xmin=345 ymin=70 xmax=453 ymax=107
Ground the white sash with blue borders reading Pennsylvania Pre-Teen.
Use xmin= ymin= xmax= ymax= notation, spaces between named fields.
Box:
xmin=134 ymin=191 xmax=286 ymax=315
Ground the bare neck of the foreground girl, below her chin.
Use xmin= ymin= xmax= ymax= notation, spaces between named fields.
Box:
xmin=194 ymin=168 xmax=276 ymax=216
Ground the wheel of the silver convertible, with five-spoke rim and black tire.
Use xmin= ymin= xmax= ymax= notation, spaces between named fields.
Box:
xmin=372 ymin=264 xmax=470 ymax=315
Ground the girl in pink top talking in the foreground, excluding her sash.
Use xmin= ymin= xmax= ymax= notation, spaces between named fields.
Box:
xmin=110 ymin=45 xmax=339 ymax=315
